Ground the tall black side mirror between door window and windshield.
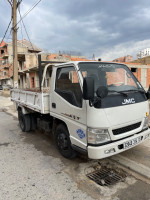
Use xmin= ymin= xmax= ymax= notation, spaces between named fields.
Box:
xmin=83 ymin=77 xmax=94 ymax=100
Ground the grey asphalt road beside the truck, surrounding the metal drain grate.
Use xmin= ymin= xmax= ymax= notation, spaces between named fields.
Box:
xmin=0 ymin=97 xmax=150 ymax=200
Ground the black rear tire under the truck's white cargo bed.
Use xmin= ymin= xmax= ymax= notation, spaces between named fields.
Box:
xmin=18 ymin=109 xmax=31 ymax=132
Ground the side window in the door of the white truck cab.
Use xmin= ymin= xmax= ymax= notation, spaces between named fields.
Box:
xmin=55 ymin=67 xmax=82 ymax=108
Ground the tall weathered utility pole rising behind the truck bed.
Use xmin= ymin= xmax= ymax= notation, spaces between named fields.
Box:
xmin=12 ymin=0 xmax=18 ymax=88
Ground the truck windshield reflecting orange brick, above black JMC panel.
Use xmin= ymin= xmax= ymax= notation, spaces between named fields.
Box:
xmin=79 ymin=62 xmax=144 ymax=95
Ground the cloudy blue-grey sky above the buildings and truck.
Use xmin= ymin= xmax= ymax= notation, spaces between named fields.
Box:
xmin=0 ymin=0 xmax=150 ymax=61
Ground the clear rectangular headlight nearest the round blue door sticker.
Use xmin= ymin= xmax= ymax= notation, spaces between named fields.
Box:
xmin=87 ymin=128 xmax=110 ymax=144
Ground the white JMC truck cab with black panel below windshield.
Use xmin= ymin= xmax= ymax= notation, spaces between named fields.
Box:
xmin=50 ymin=62 xmax=150 ymax=159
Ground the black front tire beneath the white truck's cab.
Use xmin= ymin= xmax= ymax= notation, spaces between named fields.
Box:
xmin=55 ymin=124 xmax=77 ymax=159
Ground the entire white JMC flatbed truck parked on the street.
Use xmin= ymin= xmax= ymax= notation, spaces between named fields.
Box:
xmin=11 ymin=61 xmax=150 ymax=159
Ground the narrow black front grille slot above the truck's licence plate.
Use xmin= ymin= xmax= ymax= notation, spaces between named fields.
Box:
xmin=112 ymin=122 xmax=141 ymax=135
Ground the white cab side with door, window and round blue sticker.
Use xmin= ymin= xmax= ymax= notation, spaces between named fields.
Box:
xmin=50 ymin=66 xmax=87 ymax=149
